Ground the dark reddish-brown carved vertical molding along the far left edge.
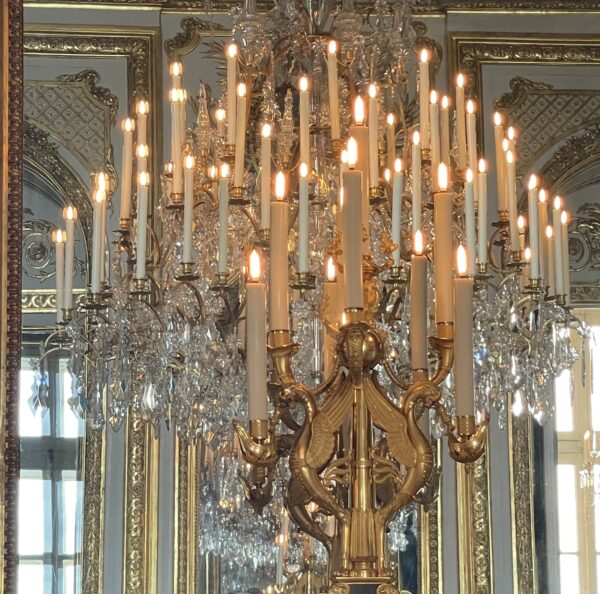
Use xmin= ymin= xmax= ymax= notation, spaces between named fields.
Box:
xmin=0 ymin=0 xmax=23 ymax=594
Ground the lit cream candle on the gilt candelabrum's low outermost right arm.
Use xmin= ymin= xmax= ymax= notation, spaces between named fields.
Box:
xmin=454 ymin=246 xmax=475 ymax=417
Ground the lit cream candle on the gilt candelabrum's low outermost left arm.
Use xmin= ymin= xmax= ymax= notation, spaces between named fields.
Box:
xmin=246 ymin=250 xmax=268 ymax=421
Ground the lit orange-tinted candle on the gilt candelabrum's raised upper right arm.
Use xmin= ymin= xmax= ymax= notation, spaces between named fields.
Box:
xmin=433 ymin=163 xmax=454 ymax=324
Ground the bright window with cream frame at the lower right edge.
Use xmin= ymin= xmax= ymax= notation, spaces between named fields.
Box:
xmin=555 ymin=310 xmax=600 ymax=594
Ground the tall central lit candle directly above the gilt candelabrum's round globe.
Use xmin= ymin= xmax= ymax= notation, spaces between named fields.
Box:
xmin=342 ymin=137 xmax=364 ymax=309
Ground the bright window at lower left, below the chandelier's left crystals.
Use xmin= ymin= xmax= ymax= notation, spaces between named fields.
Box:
xmin=18 ymin=339 xmax=84 ymax=594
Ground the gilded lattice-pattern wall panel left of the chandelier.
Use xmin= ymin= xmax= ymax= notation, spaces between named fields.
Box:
xmin=24 ymin=70 xmax=119 ymax=182
